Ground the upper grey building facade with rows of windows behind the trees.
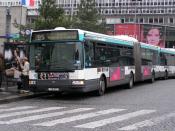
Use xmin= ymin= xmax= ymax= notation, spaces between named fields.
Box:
xmin=57 ymin=0 xmax=175 ymax=25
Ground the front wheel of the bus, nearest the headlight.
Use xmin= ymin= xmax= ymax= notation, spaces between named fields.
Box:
xmin=97 ymin=77 xmax=106 ymax=96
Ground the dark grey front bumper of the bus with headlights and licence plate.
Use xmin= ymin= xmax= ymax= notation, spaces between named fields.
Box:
xmin=29 ymin=80 xmax=98 ymax=92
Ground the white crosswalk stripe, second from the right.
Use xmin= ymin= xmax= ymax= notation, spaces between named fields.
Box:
xmin=75 ymin=110 xmax=155 ymax=129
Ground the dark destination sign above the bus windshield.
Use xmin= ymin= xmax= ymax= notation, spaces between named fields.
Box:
xmin=31 ymin=30 xmax=78 ymax=41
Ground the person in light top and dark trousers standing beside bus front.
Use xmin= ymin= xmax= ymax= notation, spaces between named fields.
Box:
xmin=21 ymin=57 xmax=30 ymax=90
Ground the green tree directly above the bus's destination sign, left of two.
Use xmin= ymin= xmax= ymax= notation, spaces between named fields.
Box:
xmin=35 ymin=0 xmax=70 ymax=30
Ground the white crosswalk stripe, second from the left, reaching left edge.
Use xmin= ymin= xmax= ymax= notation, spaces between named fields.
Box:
xmin=0 ymin=107 xmax=65 ymax=118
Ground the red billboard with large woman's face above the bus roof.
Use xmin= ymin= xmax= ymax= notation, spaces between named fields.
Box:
xmin=115 ymin=24 xmax=165 ymax=47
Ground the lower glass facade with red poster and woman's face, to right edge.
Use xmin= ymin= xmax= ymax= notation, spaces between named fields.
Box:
xmin=113 ymin=23 xmax=175 ymax=48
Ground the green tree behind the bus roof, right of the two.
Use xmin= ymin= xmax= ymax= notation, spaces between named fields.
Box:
xmin=73 ymin=0 xmax=105 ymax=33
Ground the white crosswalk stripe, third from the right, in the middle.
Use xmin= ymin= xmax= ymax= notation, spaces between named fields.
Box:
xmin=35 ymin=109 xmax=126 ymax=126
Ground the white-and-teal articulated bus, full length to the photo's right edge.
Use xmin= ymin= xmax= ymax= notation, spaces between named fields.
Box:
xmin=29 ymin=28 xmax=175 ymax=95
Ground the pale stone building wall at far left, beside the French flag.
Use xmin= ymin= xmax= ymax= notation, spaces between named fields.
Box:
xmin=0 ymin=6 xmax=27 ymax=42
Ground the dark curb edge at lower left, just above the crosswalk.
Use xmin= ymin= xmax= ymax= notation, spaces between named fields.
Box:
xmin=0 ymin=93 xmax=48 ymax=104
